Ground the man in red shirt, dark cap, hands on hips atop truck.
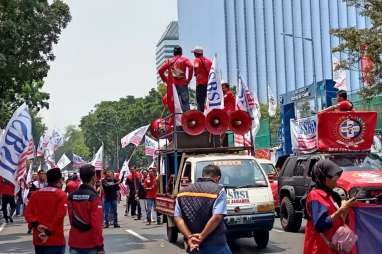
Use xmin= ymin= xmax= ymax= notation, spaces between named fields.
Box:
xmin=158 ymin=46 xmax=193 ymax=112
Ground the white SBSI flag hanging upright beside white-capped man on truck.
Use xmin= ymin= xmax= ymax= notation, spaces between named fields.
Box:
xmin=204 ymin=54 xmax=224 ymax=115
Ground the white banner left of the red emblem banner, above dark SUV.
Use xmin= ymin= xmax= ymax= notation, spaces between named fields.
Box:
xmin=290 ymin=116 xmax=318 ymax=153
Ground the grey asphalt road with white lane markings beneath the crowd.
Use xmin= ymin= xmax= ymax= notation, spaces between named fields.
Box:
xmin=0 ymin=204 xmax=304 ymax=254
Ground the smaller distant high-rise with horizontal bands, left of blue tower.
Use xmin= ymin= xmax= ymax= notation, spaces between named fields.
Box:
xmin=155 ymin=21 xmax=179 ymax=84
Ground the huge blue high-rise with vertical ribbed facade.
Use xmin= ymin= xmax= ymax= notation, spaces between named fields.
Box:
xmin=178 ymin=0 xmax=370 ymax=102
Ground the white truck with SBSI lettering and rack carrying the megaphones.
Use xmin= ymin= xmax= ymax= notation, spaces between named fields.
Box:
xmin=156 ymin=131 xmax=275 ymax=248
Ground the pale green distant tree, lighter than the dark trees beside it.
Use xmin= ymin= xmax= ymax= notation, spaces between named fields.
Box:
xmin=55 ymin=125 xmax=91 ymax=160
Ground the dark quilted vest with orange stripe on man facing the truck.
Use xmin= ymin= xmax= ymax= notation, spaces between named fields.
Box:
xmin=178 ymin=181 xmax=227 ymax=245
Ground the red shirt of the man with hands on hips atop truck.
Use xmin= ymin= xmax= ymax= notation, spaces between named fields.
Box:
xmin=158 ymin=56 xmax=194 ymax=86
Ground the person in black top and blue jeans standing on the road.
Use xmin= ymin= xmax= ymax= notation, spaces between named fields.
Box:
xmin=102 ymin=170 xmax=120 ymax=228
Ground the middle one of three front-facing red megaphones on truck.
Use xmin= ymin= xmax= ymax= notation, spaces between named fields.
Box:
xmin=206 ymin=109 xmax=229 ymax=135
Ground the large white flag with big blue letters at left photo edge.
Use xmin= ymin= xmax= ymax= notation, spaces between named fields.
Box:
xmin=0 ymin=103 xmax=33 ymax=186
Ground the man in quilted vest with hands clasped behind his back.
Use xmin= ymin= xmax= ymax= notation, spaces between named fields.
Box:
xmin=174 ymin=165 xmax=231 ymax=254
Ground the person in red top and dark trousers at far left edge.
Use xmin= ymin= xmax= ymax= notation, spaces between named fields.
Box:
xmin=0 ymin=176 xmax=16 ymax=223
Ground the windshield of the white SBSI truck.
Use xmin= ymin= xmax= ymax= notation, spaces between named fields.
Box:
xmin=196 ymin=159 xmax=268 ymax=188
